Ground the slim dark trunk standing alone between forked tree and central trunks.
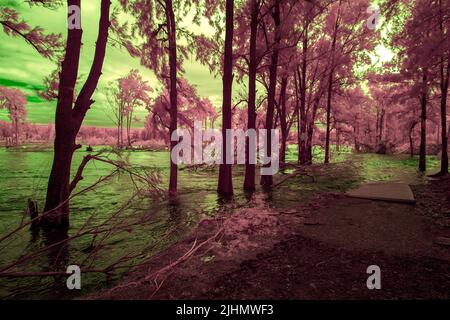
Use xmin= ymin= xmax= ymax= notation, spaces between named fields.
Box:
xmin=165 ymin=0 xmax=178 ymax=196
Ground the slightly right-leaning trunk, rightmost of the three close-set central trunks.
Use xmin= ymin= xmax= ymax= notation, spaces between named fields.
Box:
xmin=261 ymin=0 xmax=281 ymax=187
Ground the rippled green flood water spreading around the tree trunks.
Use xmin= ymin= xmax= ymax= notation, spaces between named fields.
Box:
xmin=0 ymin=147 xmax=438 ymax=298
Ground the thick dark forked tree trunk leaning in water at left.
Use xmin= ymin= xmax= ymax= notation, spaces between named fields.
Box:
xmin=41 ymin=0 xmax=111 ymax=229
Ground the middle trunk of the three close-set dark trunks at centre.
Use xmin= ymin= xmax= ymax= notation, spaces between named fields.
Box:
xmin=244 ymin=0 xmax=259 ymax=191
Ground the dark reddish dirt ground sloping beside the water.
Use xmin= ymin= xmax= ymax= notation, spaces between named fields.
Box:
xmin=95 ymin=179 xmax=450 ymax=299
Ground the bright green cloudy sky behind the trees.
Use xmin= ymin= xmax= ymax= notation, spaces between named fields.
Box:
xmin=0 ymin=0 xmax=222 ymax=126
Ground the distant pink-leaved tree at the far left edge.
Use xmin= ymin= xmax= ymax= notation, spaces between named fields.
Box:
xmin=0 ymin=86 xmax=27 ymax=145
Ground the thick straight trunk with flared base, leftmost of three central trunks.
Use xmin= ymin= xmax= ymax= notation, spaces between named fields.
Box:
xmin=217 ymin=0 xmax=234 ymax=196
